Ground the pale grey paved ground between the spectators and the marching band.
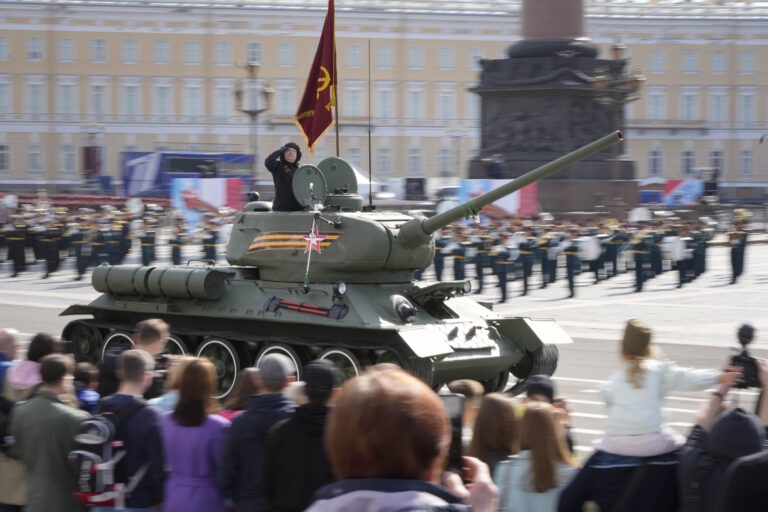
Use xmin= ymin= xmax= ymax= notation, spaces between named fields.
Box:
xmin=0 ymin=241 xmax=768 ymax=452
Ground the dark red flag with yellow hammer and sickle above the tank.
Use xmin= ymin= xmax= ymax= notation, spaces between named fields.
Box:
xmin=293 ymin=0 xmax=336 ymax=153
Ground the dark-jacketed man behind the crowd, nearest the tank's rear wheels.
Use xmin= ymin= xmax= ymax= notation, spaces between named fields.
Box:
xmin=96 ymin=318 xmax=170 ymax=400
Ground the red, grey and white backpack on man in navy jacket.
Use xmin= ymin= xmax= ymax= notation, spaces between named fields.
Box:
xmin=68 ymin=400 xmax=149 ymax=510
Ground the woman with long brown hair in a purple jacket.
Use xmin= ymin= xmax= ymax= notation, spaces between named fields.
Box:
xmin=163 ymin=359 xmax=229 ymax=512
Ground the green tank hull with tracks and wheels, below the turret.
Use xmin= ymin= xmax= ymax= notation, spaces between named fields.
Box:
xmin=62 ymin=266 xmax=570 ymax=396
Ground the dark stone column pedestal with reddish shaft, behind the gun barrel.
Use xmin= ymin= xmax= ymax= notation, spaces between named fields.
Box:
xmin=469 ymin=0 xmax=640 ymax=211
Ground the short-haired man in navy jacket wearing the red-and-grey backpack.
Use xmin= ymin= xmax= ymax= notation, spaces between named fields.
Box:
xmin=93 ymin=349 xmax=165 ymax=512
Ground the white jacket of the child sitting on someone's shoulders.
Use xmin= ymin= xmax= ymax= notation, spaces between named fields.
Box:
xmin=600 ymin=359 xmax=719 ymax=436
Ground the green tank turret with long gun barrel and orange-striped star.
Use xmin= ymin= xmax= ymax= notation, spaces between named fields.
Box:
xmin=227 ymin=132 xmax=622 ymax=283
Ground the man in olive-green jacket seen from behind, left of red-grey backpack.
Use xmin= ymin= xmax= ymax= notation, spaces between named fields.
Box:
xmin=10 ymin=354 xmax=90 ymax=512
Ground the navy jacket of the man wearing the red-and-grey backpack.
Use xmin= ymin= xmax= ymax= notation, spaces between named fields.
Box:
xmin=99 ymin=394 xmax=165 ymax=508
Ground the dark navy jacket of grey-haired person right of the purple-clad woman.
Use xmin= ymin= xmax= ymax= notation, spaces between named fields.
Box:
xmin=218 ymin=394 xmax=296 ymax=512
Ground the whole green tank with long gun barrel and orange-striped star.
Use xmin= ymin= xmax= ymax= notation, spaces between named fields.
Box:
xmin=61 ymin=132 xmax=622 ymax=397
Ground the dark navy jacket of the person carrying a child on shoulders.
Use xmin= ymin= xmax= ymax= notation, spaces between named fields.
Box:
xmin=557 ymin=451 xmax=679 ymax=512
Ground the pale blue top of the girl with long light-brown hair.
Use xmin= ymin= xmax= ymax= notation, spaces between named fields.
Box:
xmin=493 ymin=450 xmax=578 ymax=512
